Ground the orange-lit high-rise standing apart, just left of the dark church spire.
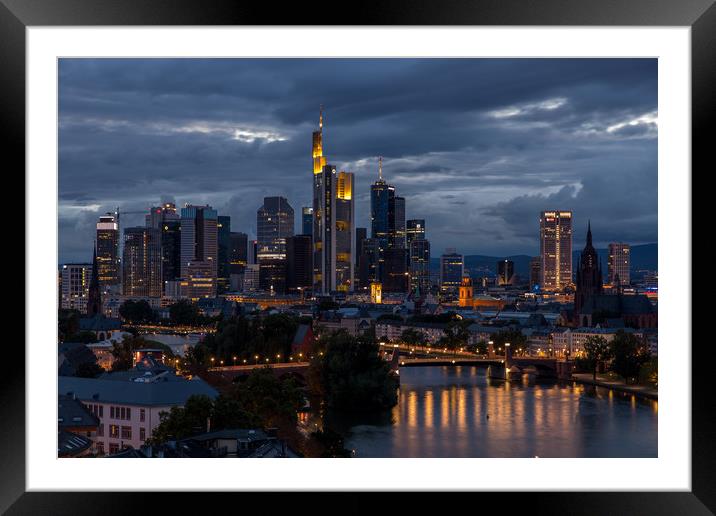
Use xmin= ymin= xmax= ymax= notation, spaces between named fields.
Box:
xmin=540 ymin=211 xmax=572 ymax=291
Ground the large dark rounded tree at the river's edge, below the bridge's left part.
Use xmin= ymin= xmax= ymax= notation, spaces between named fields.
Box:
xmin=308 ymin=330 xmax=398 ymax=411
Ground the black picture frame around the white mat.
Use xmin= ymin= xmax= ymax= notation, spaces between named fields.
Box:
xmin=0 ymin=0 xmax=716 ymax=515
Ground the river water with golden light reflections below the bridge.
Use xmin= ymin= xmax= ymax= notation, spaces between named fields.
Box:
xmin=325 ymin=366 xmax=657 ymax=457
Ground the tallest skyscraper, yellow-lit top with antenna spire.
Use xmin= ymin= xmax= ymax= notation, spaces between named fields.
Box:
xmin=312 ymin=106 xmax=355 ymax=294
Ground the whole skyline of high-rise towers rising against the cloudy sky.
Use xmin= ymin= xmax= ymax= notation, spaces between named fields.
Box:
xmin=59 ymin=108 xmax=644 ymax=312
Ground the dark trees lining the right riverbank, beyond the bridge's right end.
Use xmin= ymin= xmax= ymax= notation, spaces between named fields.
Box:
xmin=577 ymin=330 xmax=658 ymax=384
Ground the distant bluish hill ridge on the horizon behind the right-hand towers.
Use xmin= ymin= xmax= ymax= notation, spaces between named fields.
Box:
xmin=430 ymin=244 xmax=659 ymax=278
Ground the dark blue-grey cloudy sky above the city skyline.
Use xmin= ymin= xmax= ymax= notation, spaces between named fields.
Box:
xmin=59 ymin=59 xmax=657 ymax=262
